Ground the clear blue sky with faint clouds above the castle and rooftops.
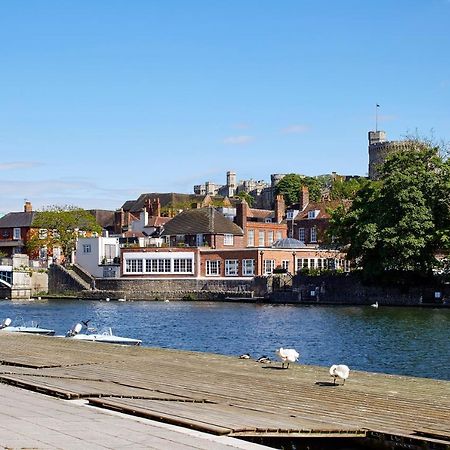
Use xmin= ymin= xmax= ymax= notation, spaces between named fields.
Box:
xmin=0 ymin=0 xmax=450 ymax=212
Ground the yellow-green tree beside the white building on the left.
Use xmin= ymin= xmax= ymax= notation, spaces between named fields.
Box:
xmin=28 ymin=205 xmax=102 ymax=257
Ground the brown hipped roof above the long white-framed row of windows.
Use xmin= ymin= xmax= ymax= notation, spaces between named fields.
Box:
xmin=161 ymin=207 xmax=244 ymax=236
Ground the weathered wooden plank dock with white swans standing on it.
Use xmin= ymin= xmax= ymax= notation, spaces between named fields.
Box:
xmin=0 ymin=333 xmax=450 ymax=449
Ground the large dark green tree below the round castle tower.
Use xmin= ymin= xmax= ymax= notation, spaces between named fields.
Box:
xmin=330 ymin=140 xmax=450 ymax=277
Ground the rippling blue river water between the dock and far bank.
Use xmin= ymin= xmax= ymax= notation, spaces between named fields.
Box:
xmin=0 ymin=300 xmax=450 ymax=380
